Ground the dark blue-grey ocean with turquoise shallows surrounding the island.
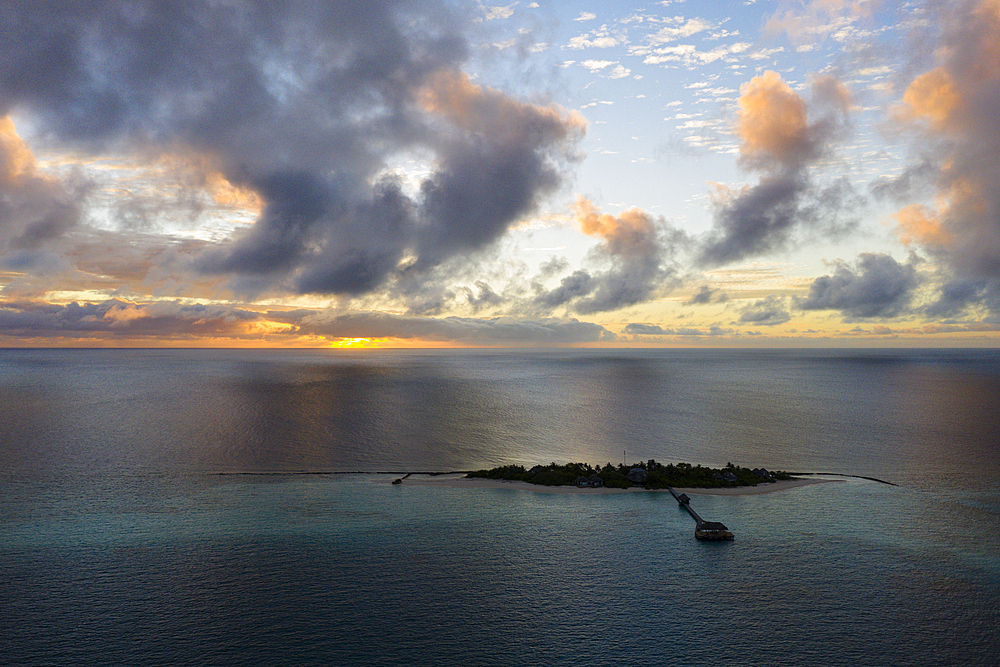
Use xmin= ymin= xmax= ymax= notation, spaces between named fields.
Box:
xmin=0 ymin=349 xmax=1000 ymax=666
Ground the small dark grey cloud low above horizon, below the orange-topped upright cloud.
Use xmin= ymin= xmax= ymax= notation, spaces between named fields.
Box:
xmin=796 ymin=253 xmax=918 ymax=321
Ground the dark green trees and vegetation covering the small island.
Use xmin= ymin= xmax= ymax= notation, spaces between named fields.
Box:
xmin=466 ymin=459 xmax=793 ymax=489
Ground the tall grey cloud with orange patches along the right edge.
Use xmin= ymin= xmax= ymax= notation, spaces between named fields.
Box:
xmin=888 ymin=0 xmax=1000 ymax=311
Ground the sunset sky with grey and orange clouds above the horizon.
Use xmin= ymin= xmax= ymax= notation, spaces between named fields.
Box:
xmin=0 ymin=0 xmax=1000 ymax=347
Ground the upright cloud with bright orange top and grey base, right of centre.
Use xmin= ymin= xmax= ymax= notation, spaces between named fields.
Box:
xmin=700 ymin=71 xmax=857 ymax=266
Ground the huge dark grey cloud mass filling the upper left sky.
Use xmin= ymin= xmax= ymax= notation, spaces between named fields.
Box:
xmin=0 ymin=0 xmax=583 ymax=295
